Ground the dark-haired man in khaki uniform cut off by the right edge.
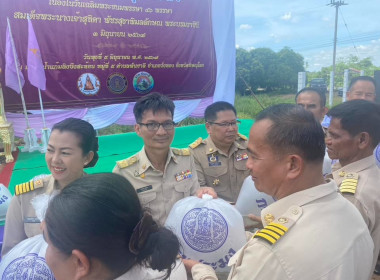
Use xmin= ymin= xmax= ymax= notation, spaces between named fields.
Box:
xmin=326 ymin=100 xmax=380 ymax=276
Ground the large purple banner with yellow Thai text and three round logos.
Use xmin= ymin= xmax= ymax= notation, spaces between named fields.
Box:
xmin=0 ymin=0 xmax=217 ymax=111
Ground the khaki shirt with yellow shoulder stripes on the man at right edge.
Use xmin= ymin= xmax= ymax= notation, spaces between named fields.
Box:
xmin=332 ymin=155 xmax=380 ymax=274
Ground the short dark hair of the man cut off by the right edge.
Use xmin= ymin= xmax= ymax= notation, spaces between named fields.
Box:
xmin=328 ymin=100 xmax=380 ymax=148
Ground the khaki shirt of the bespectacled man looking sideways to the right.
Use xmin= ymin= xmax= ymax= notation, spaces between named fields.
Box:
xmin=190 ymin=135 xmax=249 ymax=202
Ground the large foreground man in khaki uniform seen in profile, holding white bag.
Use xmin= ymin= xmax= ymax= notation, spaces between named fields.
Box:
xmin=184 ymin=104 xmax=373 ymax=280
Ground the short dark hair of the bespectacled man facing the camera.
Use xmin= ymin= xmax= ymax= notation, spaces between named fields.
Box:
xmin=133 ymin=92 xmax=175 ymax=122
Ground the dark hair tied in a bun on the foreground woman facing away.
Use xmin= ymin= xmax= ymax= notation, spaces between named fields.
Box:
xmin=45 ymin=173 xmax=179 ymax=279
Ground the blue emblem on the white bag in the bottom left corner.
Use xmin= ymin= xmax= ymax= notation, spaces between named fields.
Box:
xmin=2 ymin=253 xmax=55 ymax=280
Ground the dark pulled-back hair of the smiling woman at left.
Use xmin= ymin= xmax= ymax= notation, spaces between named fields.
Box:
xmin=51 ymin=118 xmax=99 ymax=168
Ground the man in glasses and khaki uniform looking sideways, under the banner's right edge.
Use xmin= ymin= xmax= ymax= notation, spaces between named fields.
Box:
xmin=190 ymin=101 xmax=249 ymax=202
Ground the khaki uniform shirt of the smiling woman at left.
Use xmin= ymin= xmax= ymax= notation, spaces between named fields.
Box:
xmin=1 ymin=175 xmax=57 ymax=256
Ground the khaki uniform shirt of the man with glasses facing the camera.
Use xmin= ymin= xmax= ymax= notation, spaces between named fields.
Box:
xmin=113 ymin=148 xmax=199 ymax=225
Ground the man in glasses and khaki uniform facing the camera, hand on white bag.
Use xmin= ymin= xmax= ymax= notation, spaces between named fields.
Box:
xmin=113 ymin=93 xmax=216 ymax=225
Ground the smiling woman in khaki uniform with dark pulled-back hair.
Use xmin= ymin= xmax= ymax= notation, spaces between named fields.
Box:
xmin=1 ymin=118 xmax=98 ymax=256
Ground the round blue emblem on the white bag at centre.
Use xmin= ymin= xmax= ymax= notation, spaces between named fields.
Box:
xmin=181 ymin=207 xmax=228 ymax=253
